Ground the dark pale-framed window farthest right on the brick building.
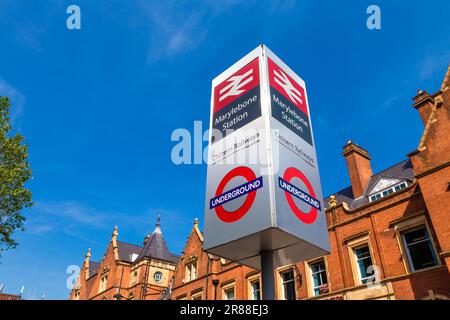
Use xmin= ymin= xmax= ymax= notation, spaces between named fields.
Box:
xmin=402 ymin=226 xmax=438 ymax=271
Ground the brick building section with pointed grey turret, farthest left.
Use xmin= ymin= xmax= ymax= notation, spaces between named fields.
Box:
xmin=70 ymin=218 xmax=179 ymax=300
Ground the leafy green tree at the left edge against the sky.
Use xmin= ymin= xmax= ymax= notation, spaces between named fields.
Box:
xmin=0 ymin=96 xmax=33 ymax=252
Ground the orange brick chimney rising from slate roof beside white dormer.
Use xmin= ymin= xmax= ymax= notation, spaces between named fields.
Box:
xmin=342 ymin=141 xmax=372 ymax=199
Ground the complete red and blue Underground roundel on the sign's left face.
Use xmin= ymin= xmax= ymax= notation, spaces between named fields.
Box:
xmin=209 ymin=166 xmax=263 ymax=223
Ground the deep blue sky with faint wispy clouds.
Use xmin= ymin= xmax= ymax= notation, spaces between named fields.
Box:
xmin=0 ymin=0 xmax=450 ymax=299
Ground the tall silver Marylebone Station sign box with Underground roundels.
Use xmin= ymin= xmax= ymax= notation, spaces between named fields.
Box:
xmin=204 ymin=45 xmax=329 ymax=268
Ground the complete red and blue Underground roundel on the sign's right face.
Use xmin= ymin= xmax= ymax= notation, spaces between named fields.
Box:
xmin=278 ymin=167 xmax=320 ymax=224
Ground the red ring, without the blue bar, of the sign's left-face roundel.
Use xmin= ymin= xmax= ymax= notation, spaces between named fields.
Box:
xmin=214 ymin=166 xmax=257 ymax=223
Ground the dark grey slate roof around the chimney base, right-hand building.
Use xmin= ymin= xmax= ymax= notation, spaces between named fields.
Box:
xmin=325 ymin=159 xmax=414 ymax=209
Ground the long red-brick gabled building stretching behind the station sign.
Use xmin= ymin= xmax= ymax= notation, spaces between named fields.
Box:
xmin=71 ymin=67 xmax=450 ymax=300
